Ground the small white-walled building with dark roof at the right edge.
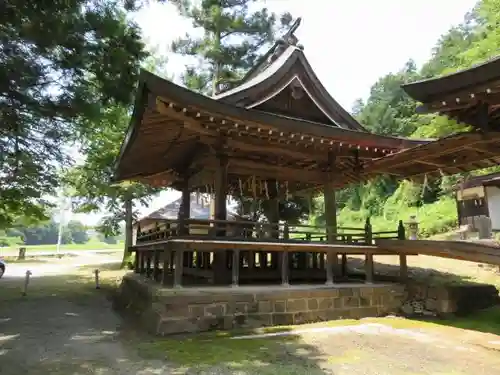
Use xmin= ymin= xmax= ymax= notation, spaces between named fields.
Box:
xmin=455 ymin=172 xmax=500 ymax=230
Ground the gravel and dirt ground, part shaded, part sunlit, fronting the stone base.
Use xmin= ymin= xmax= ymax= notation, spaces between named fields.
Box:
xmin=0 ymin=260 xmax=500 ymax=375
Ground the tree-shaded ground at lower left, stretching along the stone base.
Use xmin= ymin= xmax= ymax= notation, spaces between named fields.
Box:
xmin=0 ymin=265 xmax=332 ymax=375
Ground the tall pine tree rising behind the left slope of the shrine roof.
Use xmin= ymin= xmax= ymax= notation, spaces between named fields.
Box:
xmin=172 ymin=0 xmax=292 ymax=94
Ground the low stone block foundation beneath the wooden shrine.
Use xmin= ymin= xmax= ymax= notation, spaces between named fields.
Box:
xmin=115 ymin=274 xmax=405 ymax=335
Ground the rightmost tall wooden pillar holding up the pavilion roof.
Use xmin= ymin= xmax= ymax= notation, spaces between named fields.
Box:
xmin=323 ymin=178 xmax=338 ymax=285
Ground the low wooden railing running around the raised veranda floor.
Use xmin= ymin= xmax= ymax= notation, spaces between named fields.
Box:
xmin=136 ymin=219 xmax=405 ymax=244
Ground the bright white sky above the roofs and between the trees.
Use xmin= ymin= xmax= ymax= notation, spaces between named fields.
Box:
xmin=77 ymin=0 xmax=476 ymax=225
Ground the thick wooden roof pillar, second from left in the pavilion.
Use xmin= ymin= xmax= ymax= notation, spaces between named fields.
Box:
xmin=212 ymin=154 xmax=231 ymax=284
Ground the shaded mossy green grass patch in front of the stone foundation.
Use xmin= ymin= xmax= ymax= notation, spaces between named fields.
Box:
xmin=134 ymin=327 xmax=325 ymax=375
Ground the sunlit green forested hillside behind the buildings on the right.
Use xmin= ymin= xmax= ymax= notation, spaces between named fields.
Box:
xmin=315 ymin=0 xmax=500 ymax=235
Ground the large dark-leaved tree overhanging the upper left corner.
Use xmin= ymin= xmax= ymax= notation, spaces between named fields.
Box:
xmin=0 ymin=0 xmax=147 ymax=227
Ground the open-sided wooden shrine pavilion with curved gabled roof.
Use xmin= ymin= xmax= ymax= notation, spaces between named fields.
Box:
xmin=116 ymin=19 xmax=428 ymax=286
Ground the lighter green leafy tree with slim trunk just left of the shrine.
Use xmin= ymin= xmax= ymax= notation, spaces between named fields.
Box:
xmin=65 ymin=105 xmax=158 ymax=262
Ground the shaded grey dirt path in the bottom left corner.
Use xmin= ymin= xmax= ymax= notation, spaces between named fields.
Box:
xmin=0 ymin=296 xmax=169 ymax=375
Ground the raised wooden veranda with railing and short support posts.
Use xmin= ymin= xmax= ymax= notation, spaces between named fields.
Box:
xmin=133 ymin=219 xmax=411 ymax=287
